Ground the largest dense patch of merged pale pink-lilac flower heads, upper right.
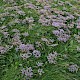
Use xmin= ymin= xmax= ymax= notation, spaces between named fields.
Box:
xmin=39 ymin=4 xmax=74 ymax=28
